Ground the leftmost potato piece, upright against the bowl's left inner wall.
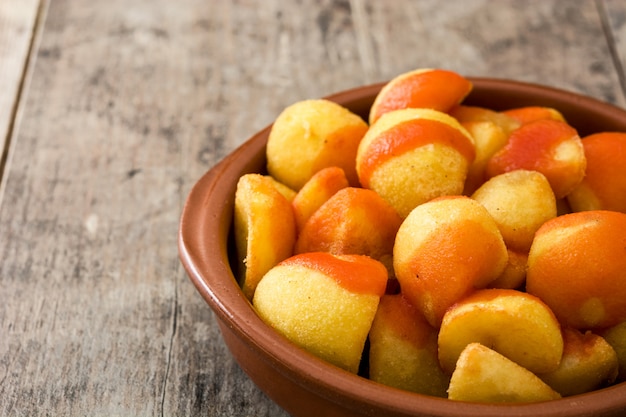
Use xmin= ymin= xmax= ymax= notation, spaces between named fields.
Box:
xmin=233 ymin=174 xmax=296 ymax=300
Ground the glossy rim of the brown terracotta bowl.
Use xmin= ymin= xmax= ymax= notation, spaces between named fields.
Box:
xmin=178 ymin=77 xmax=626 ymax=417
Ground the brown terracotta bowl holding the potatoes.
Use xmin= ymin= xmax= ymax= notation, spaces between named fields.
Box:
xmin=179 ymin=78 xmax=626 ymax=417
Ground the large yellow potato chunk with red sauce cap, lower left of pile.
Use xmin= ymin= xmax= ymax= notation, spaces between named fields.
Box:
xmin=252 ymin=252 xmax=387 ymax=373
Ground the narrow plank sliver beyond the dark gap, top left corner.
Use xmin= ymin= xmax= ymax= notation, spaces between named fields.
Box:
xmin=0 ymin=0 xmax=39 ymax=179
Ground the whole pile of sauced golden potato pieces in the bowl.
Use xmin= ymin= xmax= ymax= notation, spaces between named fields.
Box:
xmin=234 ymin=69 xmax=626 ymax=402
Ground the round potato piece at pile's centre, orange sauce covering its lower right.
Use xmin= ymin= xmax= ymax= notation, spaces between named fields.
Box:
xmin=392 ymin=197 xmax=508 ymax=326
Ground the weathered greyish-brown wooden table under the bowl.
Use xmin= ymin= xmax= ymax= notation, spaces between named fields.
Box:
xmin=0 ymin=0 xmax=626 ymax=416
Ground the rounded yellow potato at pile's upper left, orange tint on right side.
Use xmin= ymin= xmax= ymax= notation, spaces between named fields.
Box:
xmin=266 ymin=99 xmax=368 ymax=191
